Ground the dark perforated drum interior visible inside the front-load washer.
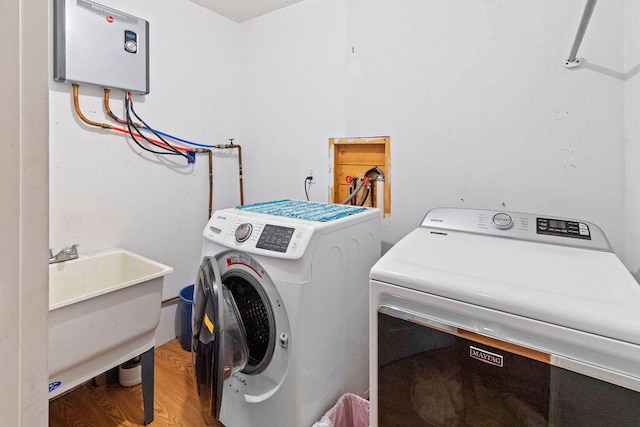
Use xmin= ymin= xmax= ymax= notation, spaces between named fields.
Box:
xmin=222 ymin=270 xmax=275 ymax=374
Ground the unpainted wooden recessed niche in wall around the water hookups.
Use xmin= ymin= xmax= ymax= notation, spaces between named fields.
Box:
xmin=329 ymin=136 xmax=391 ymax=218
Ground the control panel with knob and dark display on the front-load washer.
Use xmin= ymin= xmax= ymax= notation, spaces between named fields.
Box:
xmin=203 ymin=210 xmax=314 ymax=259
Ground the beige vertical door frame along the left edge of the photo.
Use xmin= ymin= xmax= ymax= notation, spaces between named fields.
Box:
xmin=0 ymin=0 xmax=49 ymax=427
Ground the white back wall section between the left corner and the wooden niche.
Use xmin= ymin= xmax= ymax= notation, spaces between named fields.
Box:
xmin=240 ymin=0 xmax=347 ymax=203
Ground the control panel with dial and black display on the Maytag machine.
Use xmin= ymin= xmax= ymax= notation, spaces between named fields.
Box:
xmin=421 ymin=208 xmax=612 ymax=252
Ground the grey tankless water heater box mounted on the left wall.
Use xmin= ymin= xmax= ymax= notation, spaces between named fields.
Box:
xmin=53 ymin=0 xmax=149 ymax=94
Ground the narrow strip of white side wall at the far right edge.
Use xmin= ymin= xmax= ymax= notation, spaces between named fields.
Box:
xmin=624 ymin=0 xmax=640 ymax=280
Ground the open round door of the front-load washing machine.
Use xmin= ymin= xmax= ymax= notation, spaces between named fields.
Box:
xmin=191 ymin=257 xmax=249 ymax=424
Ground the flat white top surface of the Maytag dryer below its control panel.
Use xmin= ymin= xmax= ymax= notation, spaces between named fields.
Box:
xmin=370 ymin=227 xmax=640 ymax=344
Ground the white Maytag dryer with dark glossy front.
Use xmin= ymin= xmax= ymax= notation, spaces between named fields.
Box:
xmin=370 ymin=208 xmax=640 ymax=426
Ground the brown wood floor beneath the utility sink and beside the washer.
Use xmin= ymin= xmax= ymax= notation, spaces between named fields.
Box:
xmin=49 ymin=339 xmax=224 ymax=427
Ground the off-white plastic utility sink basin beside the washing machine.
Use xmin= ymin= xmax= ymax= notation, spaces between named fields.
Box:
xmin=49 ymin=248 xmax=173 ymax=398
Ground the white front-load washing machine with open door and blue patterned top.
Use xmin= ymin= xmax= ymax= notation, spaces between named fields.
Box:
xmin=192 ymin=200 xmax=381 ymax=427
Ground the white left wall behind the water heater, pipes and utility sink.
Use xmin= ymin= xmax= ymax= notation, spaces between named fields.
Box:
xmin=50 ymin=0 xmax=239 ymax=318
